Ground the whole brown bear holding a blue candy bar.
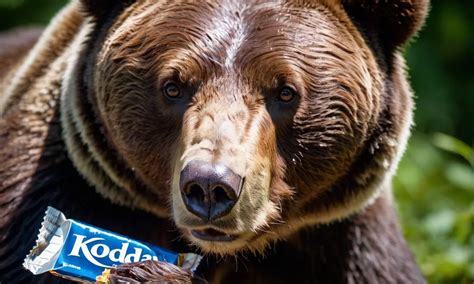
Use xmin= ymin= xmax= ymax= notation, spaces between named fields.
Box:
xmin=0 ymin=0 xmax=428 ymax=283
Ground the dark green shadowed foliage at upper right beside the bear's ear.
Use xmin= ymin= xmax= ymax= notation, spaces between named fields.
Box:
xmin=406 ymin=0 xmax=474 ymax=143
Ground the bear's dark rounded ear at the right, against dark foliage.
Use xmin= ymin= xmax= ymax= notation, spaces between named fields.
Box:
xmin=341 ymin=0 xmax=429 ymax=55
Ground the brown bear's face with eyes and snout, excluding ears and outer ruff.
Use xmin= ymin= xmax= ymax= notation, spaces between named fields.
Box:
xmin=81 ymin=0 xmax=414 ymax=253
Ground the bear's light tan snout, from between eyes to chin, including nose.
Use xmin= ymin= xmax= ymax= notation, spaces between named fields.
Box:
xmin=171 ymin=90 xmax=281 ymax=251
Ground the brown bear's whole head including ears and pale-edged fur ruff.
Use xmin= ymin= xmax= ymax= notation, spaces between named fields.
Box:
xmin=62 ymin=0 xmax=428 ymax=254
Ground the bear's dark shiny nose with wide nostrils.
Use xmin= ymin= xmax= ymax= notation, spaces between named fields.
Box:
xmin=179 ymin=161 xmax=243 ymax=221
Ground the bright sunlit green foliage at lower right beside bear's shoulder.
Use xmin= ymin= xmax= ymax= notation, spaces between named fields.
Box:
xmin=394 ymin=133 xmax=474 ymax=283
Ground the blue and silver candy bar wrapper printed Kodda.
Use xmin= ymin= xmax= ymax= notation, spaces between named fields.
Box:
xmin=23 ymin=207 xmax=202 ymax=282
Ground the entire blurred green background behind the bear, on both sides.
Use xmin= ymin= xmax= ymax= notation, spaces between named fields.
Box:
xmin=0 ymin=0 xmax=474 ymax=283
